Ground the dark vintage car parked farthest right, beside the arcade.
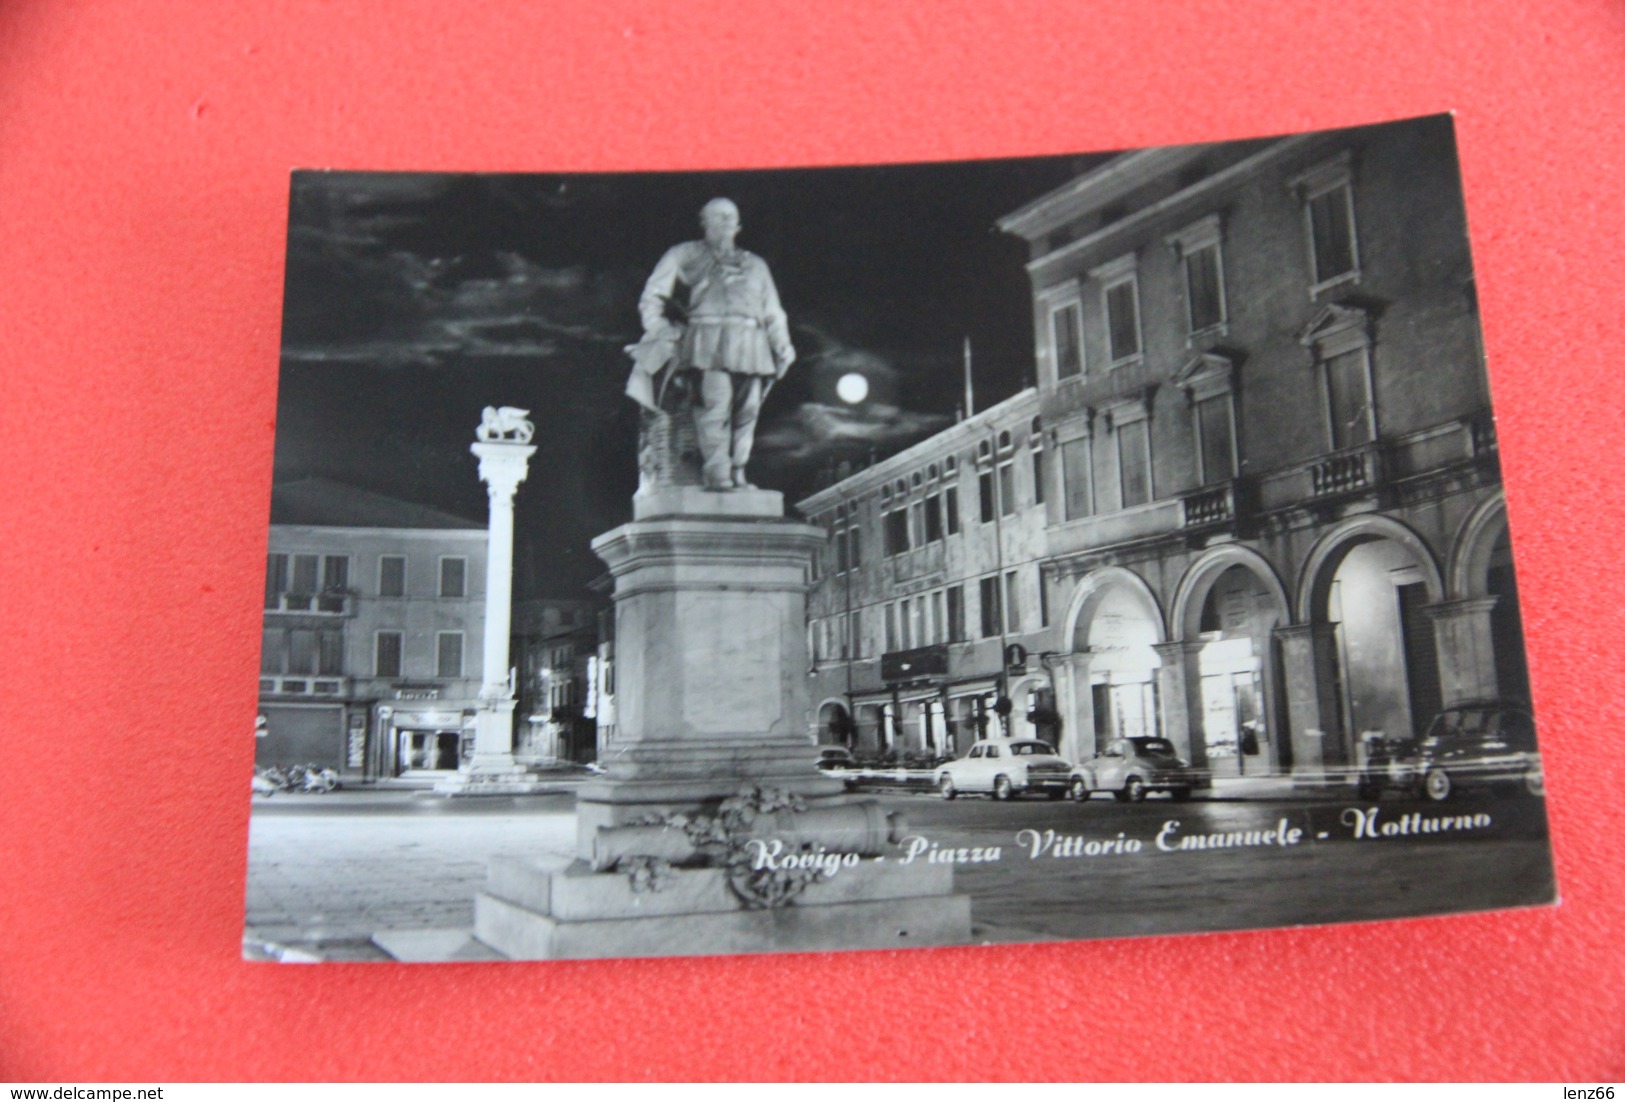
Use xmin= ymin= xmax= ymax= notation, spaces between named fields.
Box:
xmin=1411 ymin=701 xmax=1545 ymax=800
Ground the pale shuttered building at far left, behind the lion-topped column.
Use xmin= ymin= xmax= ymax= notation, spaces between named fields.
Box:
xmin=255 ymin=479 xmax=486 ymax=779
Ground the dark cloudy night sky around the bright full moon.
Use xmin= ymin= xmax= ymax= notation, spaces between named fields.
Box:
xmin=275 ymin=156 xmax=1102 ymax=597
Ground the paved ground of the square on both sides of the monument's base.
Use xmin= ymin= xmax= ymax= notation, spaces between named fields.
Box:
xmin=244 ymin=793 xmax=1555 ymax=961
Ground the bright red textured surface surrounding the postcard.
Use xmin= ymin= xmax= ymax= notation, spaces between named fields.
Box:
xmin=0 ymin=0 xmax=1625 ymax=1081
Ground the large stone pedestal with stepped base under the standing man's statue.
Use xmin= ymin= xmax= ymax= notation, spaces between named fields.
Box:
xmin=475 ymin=486 xmax=970 ymax=959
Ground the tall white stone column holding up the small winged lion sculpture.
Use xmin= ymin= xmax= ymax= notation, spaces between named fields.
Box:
xmin=434 ymin=431 xmax=536 ymax=795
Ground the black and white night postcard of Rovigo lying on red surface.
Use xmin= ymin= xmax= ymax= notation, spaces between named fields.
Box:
xmin=244 ymin=115 xmax=1557 ymax=962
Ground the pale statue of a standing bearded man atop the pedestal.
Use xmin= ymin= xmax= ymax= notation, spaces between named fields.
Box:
xmin=627 ymin=198 xmax=796 ymax=491
